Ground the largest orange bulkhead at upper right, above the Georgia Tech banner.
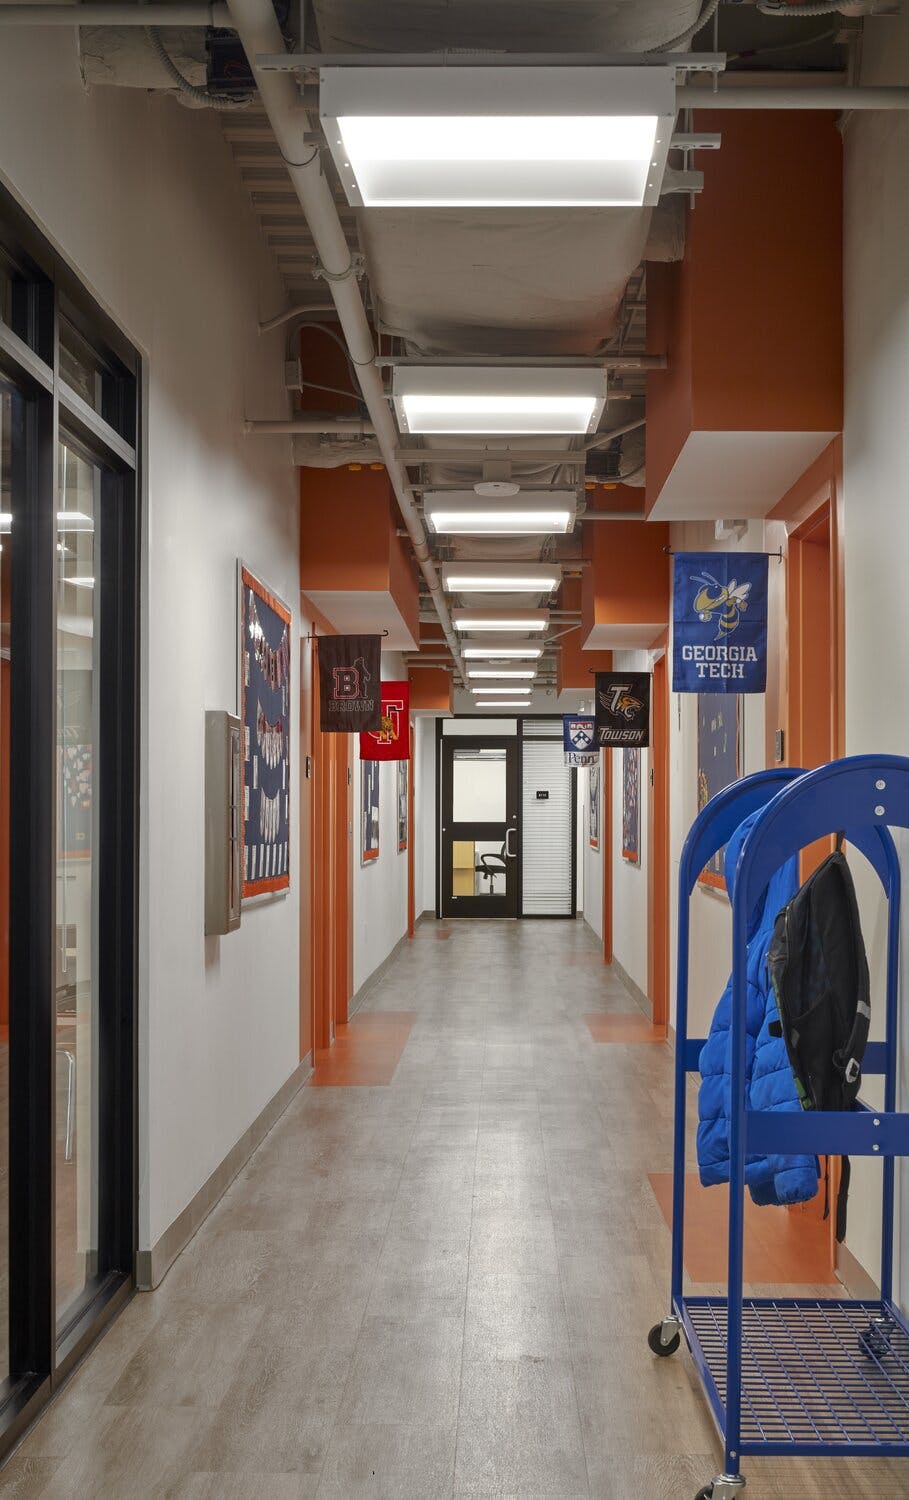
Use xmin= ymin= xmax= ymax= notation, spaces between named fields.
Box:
xmin=647 ymin=110 xmax=843 ymax=510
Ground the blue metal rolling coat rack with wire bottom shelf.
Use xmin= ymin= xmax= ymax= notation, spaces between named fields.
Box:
xmin=648 ymin=756 xmax=909 ymax=1500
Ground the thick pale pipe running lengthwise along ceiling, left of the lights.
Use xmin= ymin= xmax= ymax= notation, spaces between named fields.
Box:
xmin=228 ymin=0 xmax=467 ymax=681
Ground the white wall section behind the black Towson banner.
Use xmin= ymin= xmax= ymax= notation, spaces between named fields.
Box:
xmin=615 ymin=651 xmax=653 ymax=995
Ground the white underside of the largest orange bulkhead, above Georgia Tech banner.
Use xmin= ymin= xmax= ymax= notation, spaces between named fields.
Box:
xmin=648 ymin=432 xmax=836 ymax=521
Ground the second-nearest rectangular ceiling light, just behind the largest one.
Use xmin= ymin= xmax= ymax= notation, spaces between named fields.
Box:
xmin=392 ymin=365 xmax=606 ymax=438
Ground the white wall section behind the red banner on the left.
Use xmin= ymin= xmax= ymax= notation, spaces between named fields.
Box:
xmin=353 ymin=651 xmax=407 ymax=995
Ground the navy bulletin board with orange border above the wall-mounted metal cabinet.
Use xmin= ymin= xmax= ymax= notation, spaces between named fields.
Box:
xmin=240 ymin=564 xmax=291 ymax=897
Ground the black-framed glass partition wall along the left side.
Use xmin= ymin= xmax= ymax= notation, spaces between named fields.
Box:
xmin=0 ymin=191 xmax=140 ymax=1454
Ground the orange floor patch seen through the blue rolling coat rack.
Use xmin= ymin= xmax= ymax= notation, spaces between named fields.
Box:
xmin=648 ymin=1172 xmax=837 ymax=1286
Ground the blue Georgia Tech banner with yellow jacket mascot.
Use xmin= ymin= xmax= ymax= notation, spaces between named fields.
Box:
xmin=672 ymin=552 xmax=768 ymax=693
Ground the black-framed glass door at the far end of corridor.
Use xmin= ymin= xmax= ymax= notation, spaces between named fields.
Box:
xmin=441 ymin=735 xmax=518 ymax=917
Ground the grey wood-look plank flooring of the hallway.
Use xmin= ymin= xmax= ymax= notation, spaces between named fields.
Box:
xmin=0 ymin=921 xmax=906 ymax=1500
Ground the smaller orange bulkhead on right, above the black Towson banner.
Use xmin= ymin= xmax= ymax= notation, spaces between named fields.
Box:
xmin=581 ymin=521 xmax=669 ymax=641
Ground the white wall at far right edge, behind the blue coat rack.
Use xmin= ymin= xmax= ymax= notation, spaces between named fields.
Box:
xmin=843 ymin=32 xmax=909 ymax=1307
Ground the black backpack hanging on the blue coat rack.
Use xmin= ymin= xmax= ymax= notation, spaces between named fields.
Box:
xmin=767 ymin=840 xmax=872 ymax=1241
